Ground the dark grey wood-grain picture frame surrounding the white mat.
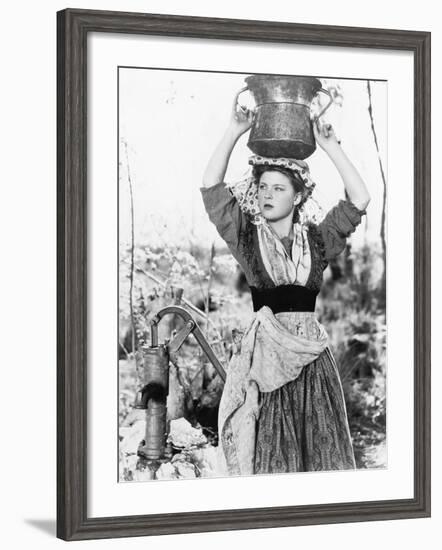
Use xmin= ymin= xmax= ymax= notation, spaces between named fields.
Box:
xmin=57 ymin=9 xmax=431 ymax=540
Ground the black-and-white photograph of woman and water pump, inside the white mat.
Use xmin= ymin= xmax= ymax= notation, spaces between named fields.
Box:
xmin=115 ymin=65 xmax=388 ymax=483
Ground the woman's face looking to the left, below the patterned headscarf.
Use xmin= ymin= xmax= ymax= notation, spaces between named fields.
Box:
xmin=258 ymin=170 xmax=301 ymax=222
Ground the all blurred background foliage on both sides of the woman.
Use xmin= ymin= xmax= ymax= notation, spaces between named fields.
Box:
xmin=120 ymin=239 xmax=386 ymax=468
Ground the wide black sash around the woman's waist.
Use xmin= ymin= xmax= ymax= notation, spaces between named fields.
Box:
xmin=250 ymin=285 xmax=317 ymax=313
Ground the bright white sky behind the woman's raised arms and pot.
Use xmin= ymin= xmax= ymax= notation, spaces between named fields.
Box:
xmin=119 ymin=68 xmax=388 ymax=253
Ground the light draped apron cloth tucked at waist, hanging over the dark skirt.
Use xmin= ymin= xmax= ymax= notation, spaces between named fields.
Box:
xmin=218 ymin=306 xmax=328 ymax=475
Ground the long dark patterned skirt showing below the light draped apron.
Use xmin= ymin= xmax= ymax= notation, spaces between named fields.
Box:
xmin=254 ymin=348 xmax=355 ymax=474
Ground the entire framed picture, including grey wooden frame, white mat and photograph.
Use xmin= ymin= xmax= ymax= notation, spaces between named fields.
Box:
xmin=57 ymin=9 xmax=431 ymax=540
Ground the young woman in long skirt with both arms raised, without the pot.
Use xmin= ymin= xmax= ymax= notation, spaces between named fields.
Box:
xmin=201 ymin=90 xmax=370 ymax=475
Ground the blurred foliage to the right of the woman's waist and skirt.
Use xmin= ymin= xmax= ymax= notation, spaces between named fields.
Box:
xmin=318 ymin=245 xmax=386 ymax=468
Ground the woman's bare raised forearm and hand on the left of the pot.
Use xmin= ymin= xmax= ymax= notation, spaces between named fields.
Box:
xmin=203 ymin=87 xmax=254 ymax=187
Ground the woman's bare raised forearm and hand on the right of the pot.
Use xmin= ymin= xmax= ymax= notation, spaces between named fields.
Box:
xmin=313 ymin=119 xmax=370 ymax=210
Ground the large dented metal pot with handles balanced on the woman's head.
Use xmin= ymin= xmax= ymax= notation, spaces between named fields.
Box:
xmin=245 ymin=75 xmax=333 ymax=160
